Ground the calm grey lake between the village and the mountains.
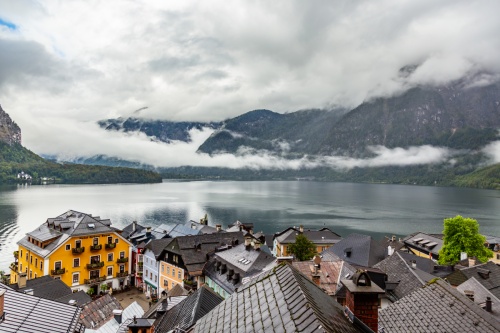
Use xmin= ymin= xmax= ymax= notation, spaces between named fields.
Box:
xmin=0 ymin=181 xmax=500 ymax=272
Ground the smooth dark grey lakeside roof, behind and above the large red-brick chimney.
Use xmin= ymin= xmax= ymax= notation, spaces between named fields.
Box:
xmin=321 ymin=234 xmax=387 ymax=267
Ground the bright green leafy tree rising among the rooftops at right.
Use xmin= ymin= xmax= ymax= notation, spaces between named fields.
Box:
xmin=439 ymin=215 xmax=493 ymax=264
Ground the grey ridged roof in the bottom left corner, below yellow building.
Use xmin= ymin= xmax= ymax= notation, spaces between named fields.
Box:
xmin=0 ymin=284 xmax=83 ymax=333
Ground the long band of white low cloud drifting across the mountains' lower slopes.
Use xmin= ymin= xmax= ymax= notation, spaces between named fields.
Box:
xmin=31 ymin=120 xmax=458 ymax=170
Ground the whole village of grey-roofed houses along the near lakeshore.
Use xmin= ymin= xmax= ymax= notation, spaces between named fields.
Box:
xmin=0 ymin=210 xmax=500 ymax=333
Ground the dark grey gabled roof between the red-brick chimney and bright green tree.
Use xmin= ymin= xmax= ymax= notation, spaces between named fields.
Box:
xmin=374 ymin=252 xmax=435 ymax=299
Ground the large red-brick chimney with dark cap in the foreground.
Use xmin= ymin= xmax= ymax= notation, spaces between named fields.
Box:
xmin=341 ymin=270 xmax=384 ymax=332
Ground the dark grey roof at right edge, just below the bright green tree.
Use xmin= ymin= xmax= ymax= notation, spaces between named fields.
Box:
xmin=446 ymin=261 xmax=500 ymax=298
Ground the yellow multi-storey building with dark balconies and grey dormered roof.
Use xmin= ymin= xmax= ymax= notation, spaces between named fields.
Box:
xmin=10 ymin=210 xmax=132 ymax=293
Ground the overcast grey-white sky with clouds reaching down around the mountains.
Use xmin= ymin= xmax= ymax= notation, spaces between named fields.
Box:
xmin=0 ymin=0 xmax=500 ymax=167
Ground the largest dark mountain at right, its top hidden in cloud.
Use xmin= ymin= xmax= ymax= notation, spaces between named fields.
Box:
xmin=316 ymin=81 xmax=500 ymax=154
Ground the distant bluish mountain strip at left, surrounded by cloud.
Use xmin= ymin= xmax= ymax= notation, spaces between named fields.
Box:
xmin=98 ymin=117 xmax=222 ymax=143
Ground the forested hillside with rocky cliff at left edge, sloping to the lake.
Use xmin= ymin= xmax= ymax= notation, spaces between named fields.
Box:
xmin=0 ymin=107 xmax=162 ymax=184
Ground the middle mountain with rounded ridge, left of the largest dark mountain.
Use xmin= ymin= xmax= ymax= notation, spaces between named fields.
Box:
xmin=198 ymin=109 xmax=345 ymax=155
